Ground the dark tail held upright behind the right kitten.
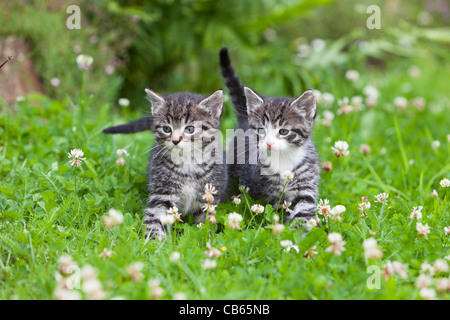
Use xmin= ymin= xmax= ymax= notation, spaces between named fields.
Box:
xmin=219 ymin=48 xmax=247 ymax=124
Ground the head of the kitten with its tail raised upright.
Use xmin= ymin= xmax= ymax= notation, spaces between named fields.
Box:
xmin=244 ymin=87 xmax=316 ymax=152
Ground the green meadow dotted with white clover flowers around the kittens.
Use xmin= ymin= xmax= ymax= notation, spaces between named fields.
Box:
xmin=0 ymin=1 xmax=450 ymax=300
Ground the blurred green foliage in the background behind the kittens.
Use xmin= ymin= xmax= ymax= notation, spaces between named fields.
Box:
xmin=0 ymin=0 xmax=450 ymax=122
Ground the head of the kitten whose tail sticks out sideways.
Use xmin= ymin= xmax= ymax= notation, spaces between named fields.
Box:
xmin=145 ymin=89 xmax=224 ymax=150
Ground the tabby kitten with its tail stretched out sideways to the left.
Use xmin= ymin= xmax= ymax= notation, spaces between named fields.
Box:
xmin=103 ymin=89 xmax=229 ymax=239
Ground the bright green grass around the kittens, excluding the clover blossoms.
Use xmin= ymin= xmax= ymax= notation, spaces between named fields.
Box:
xmin=0 ymin=53 xmax=450 ymax=299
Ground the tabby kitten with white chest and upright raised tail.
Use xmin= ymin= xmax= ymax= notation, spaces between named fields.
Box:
xmin=220 ymin=48 xmax=320 ymax=224
